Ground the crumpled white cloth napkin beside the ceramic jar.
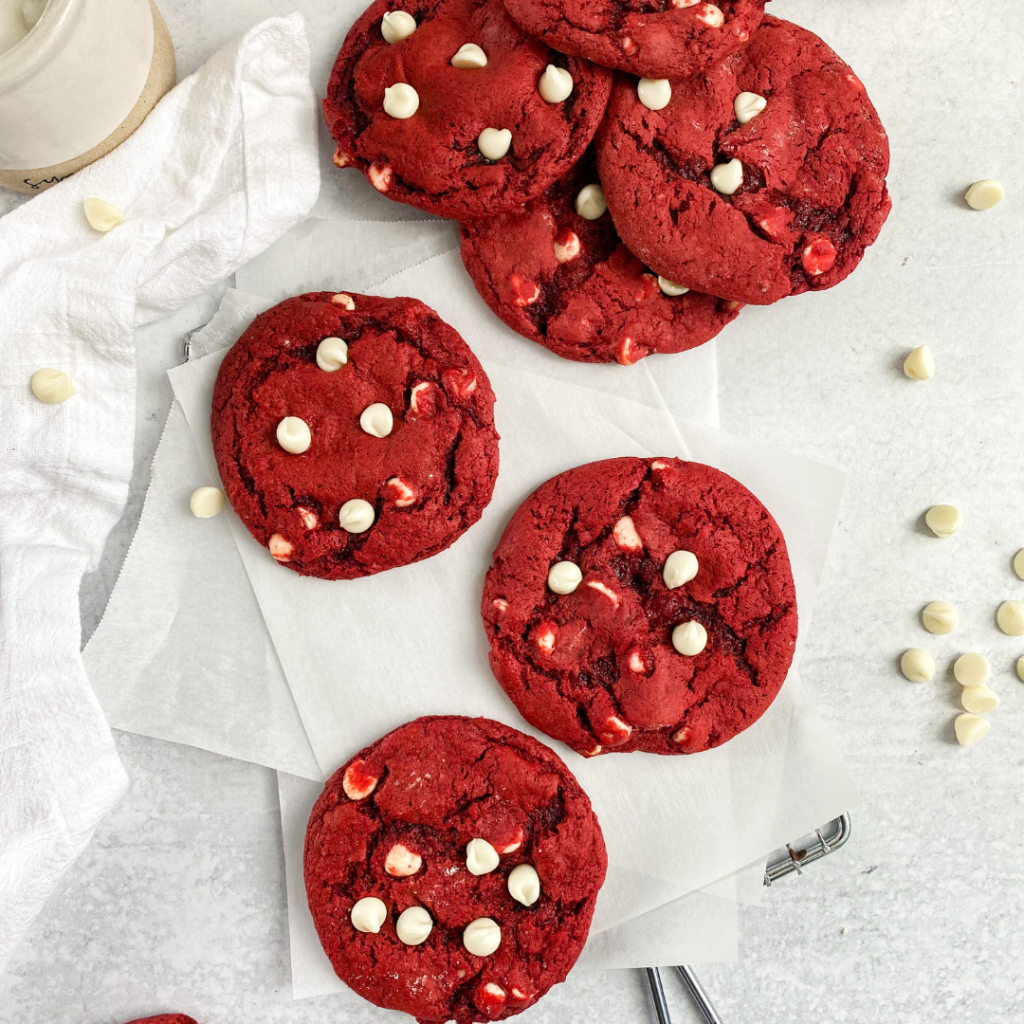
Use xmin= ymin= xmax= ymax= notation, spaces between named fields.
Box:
xmin=0 ymin=14 xmax=319 ymax=969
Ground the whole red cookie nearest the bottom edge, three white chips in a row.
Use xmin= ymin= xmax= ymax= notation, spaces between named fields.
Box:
xmin=304 ymin=717 xmax=607 ymax=1022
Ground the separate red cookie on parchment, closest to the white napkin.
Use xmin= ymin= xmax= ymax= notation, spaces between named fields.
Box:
xmin=211 ymin=292 xmax=498 ymax=580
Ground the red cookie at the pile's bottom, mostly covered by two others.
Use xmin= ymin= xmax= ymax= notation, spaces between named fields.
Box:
xmin=462 ymin=150 xmax=739 ymax=366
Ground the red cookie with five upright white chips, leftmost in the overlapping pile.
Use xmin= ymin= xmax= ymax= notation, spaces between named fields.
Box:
xmin=324 ymin=0 xmax=611 ymax=219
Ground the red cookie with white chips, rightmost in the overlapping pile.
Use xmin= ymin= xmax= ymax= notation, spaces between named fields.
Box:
xmin=597 ymin=17 xmax=891 ymax=304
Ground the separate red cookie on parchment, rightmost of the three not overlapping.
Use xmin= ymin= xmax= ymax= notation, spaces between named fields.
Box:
xmin=482 ymin=459 xmax=797 ymax=755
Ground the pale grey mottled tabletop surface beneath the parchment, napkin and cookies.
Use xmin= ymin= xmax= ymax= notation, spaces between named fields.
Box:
xmin=0 ymin=0 xmax=1024 ymax=1024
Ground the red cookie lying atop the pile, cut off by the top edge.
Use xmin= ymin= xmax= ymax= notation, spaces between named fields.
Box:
xmin=505 ymin=0 xmax=765 ymax=78
